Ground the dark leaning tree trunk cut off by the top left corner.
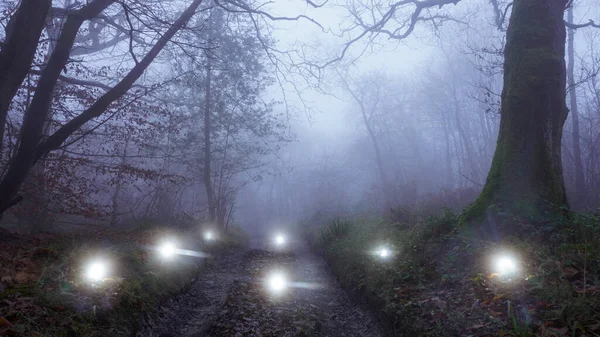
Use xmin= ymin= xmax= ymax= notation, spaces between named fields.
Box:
xmin=0 ymin=0 xmax=52 ymax=149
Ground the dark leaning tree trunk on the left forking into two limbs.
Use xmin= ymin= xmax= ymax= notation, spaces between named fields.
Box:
xmin=0 ymin=0 xmax=202 ymax=213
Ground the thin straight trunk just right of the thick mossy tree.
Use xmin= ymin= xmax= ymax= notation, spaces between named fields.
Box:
xmin=567 ymin=6 xmax=586 ymax=207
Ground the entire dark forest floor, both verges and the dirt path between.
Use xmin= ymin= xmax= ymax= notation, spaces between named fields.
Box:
xmin=0 ymin=211 xmax=600 ymax=337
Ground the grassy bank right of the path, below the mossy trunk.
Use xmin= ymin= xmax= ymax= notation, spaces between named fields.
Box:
xmin=308 ymin=210 xmax=600 ymax=336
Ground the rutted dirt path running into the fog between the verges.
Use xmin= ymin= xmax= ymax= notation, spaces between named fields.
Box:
xmin=138 ymin=241 xmax=383 ymax=337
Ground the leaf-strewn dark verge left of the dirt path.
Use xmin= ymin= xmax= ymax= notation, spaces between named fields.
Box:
xmin=0 ymin=224 xmax=246 ymax=337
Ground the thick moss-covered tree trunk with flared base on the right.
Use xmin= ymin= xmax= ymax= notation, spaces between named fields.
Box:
xmin=462 ymin=0 xmax=568 ymax=225
